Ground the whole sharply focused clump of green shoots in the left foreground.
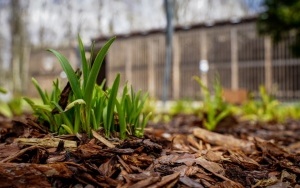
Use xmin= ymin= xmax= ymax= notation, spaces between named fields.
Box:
xmin=25 ymin=37 xmax=150 ymax=139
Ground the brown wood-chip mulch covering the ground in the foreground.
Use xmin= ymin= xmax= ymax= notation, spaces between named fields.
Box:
xmin=0 ymin=115 xmax=300 ymax=188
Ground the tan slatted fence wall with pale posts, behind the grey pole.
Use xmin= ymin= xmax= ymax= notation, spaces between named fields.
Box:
xmin=106 ymin=20 xmax=300 ymax=100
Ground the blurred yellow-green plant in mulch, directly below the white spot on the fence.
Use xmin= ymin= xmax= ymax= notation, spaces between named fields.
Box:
xmin=193 ymin=76 xmax=231 ymax=130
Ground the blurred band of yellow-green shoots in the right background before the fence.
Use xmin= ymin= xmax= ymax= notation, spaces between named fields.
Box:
xmin=170 ymin=76 xmax=300 ymax=130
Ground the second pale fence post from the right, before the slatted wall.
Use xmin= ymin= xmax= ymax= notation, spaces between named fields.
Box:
xmin=230 ymin=26 xmax=239 ymax=90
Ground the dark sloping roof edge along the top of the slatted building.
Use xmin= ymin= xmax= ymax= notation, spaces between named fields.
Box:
xmin=92 ymin=15 xmax=257 ymax=43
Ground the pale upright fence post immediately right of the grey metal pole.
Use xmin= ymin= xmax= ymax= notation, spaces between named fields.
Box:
xmin=173 ymin=34 xmax=180 ymax=99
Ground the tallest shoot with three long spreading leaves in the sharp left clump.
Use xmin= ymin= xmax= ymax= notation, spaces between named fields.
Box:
xmin=49 ymin=37 xmax=115 ymax=136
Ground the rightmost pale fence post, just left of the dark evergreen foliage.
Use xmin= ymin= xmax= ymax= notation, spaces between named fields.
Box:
xmin=264 ymin=36 xmax=272 ymax=92
